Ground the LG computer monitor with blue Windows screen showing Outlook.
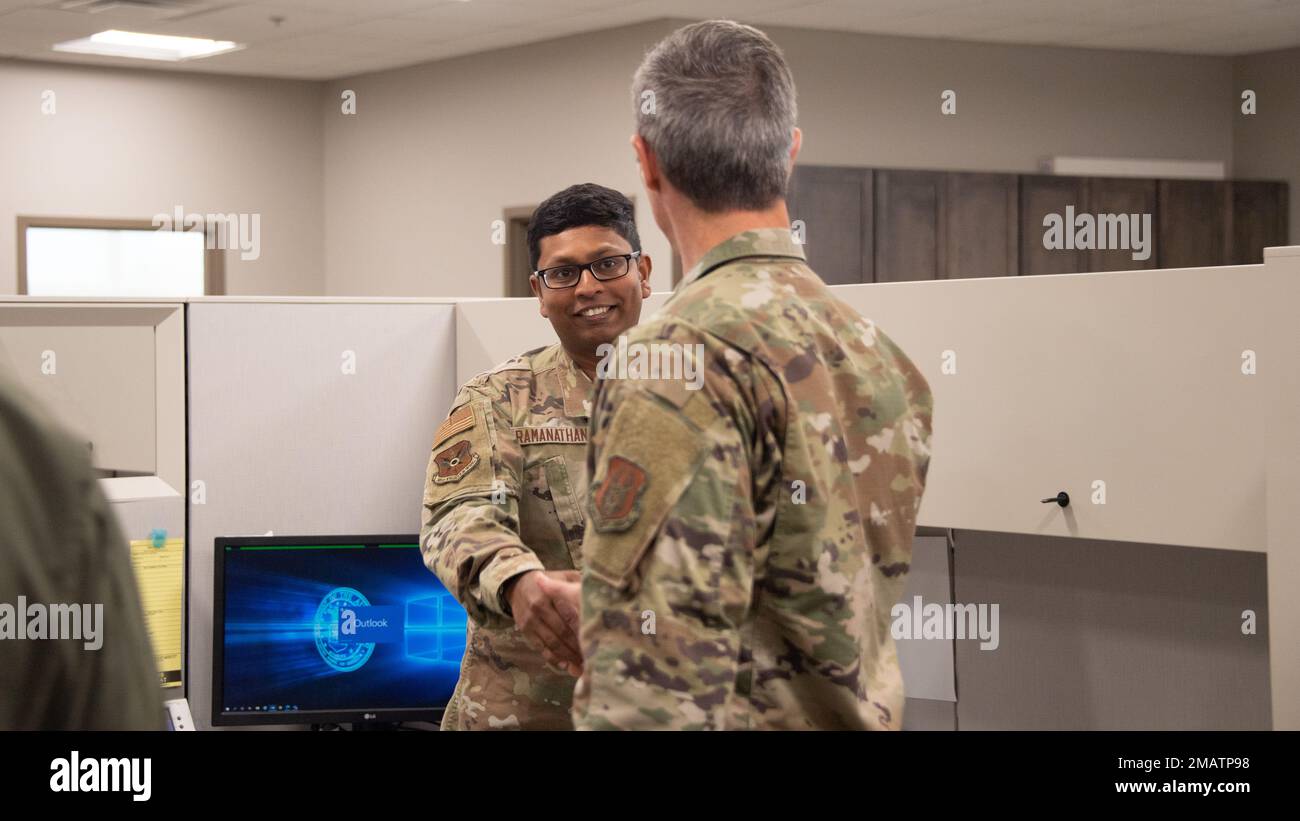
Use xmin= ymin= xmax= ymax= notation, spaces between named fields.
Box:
xmin=212 ymin=535 xmax=465 ymax=726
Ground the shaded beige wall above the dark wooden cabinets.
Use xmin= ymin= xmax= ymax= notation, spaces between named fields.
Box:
xmin=767 ymin=29 xmax=1235 ymax=173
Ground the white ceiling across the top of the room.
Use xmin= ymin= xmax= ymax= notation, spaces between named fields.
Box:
xmin=0 ymin=0 xmax=1300 ymax=79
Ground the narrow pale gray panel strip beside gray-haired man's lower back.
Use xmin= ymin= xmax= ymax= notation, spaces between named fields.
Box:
xmin=891 ymin=537 xmax=957 ymax=701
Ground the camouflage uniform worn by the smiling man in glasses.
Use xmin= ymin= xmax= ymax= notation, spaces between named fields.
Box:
xmin=420 ymin=344 xmax=592 ymax=729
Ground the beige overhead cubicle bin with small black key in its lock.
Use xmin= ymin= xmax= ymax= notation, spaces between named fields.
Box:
xmin=832 ymin=259 xmax=1274 ymax=552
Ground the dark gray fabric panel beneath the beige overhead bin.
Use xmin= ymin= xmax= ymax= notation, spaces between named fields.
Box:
xmin=953 ymin=530 xmax=1270 ymax=730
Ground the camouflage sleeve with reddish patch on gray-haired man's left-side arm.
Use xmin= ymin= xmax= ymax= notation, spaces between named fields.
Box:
xmin=573 ymin=323 xmax=753 ymax=729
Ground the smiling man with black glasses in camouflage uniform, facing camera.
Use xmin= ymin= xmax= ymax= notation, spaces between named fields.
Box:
xmin=420 ymin=183 xmax=650 ymax=729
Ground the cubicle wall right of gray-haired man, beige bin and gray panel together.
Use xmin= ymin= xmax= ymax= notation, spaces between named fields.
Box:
xmin=836 ymin=247 xmax=1300 ymax=729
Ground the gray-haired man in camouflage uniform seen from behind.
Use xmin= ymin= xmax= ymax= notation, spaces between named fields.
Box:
xmin=573 ymin=21 xmax=932 ymax=729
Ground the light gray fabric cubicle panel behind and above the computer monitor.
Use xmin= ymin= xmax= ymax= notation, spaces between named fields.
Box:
xmin=187 ymin=303 xmax=456 ymax=729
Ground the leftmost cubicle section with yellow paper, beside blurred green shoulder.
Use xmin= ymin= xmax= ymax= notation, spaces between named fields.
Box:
xmin=0 ymin=297 xmax=186 ymax=696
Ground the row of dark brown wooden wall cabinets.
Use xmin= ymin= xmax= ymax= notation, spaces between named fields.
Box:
xmin=788 ymin=166 xmax=1288 ymax=284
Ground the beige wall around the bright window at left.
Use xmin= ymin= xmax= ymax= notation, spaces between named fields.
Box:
xmin=0 ymin=60 xmax=324 ymax=294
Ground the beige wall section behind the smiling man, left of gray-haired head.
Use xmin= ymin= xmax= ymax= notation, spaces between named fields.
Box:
xmin=321 ymin=22 xmax=673 ymax=296
